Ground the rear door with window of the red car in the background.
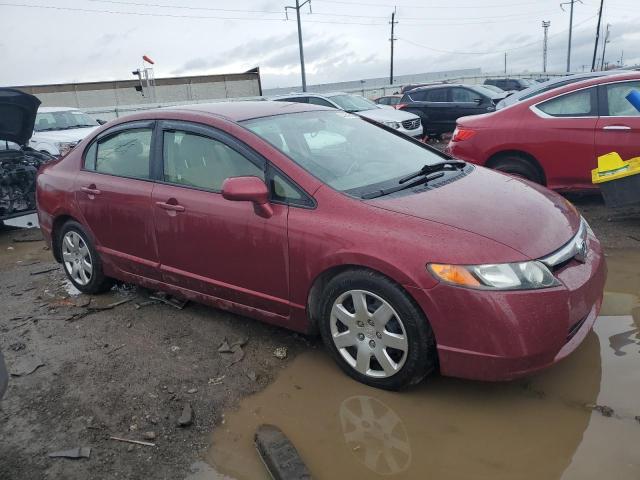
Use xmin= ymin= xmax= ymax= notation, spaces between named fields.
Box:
xmin=531 ymin=87 xmax=598 ymax=189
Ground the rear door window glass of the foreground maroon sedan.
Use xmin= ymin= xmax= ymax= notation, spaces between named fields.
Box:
xmin=90 ymin=128 xmax=152 ymax=179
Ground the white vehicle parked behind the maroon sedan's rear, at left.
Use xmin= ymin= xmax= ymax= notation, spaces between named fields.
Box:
xmin=29 ymin=107 xmax=100 ymax=156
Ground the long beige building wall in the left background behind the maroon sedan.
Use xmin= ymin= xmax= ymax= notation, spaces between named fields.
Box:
xmin=14 ymin=73 xmax=261 ymax=109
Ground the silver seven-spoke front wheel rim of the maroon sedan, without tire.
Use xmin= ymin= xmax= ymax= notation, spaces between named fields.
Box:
xmin=330 ymin=290 xmax=409 ymax=378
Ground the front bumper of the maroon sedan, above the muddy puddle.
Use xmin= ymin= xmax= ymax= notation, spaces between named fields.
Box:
xmin=412 ymin=236 xmax=606 ymax=380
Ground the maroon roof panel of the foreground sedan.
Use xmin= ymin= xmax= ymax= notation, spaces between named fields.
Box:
xmin=162 ymin=100 xmax=333 ymax=122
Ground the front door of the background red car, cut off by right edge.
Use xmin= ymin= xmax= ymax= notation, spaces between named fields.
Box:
xmin=594 ymin=80 xmax=640 ymax=163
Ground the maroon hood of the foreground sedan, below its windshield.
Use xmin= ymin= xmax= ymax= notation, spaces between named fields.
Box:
xmin=367 ymin=166 xmax=580 ymax=261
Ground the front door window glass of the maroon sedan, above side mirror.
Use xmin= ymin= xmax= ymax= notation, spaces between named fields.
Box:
xmin=163 ymin=130 xmax=264 ymax=191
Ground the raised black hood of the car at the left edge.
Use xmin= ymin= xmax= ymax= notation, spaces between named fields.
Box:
xmin=0 ymin=88 xmax=40 ymax=145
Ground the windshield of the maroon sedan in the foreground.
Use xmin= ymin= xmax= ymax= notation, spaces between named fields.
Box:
xmin=243 ymin=111 xmax=443 ymax=197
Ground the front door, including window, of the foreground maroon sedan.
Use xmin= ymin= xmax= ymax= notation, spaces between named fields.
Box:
xmin=153 ymin=122 xmax=289 ymax=315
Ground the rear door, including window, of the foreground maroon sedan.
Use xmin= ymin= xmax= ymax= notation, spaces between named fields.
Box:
xmin=75 ymin=121 xmax=159 ymax=278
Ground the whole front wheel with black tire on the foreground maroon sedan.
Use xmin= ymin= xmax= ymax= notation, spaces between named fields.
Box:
xmin=319 ymin=270 xmax=436 ymax=390
